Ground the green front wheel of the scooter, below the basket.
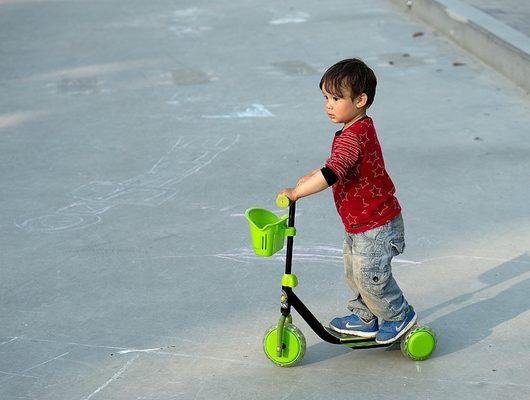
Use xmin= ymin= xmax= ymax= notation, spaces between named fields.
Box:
xmin=263 ymin=323 xmax=306 ymax=367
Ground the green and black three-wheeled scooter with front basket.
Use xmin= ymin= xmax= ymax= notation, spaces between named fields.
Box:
xmin=245 ymin=195 xmax=436 ymax=367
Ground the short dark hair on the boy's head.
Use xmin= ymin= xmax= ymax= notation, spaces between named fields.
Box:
xmin=319 ymin=58 xmax=377 ymax=108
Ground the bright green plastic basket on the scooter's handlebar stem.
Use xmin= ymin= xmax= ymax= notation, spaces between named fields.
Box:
xmin=245 ymin=208 xmax=296 ymax=257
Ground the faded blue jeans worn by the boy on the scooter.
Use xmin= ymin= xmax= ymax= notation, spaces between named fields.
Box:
xmin=343 ymin=214 xmax=408 ymax=323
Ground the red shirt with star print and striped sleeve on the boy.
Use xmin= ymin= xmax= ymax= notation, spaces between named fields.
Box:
xmin=326 ymin=117 xmax=401 ymax=233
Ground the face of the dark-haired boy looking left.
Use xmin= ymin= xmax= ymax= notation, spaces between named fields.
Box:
xmin=322 ymin=88 xmax=366 ymax=129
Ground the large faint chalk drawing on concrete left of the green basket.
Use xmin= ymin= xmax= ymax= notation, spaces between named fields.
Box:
xmin=15 ymin=134 xmax=241 ymax=233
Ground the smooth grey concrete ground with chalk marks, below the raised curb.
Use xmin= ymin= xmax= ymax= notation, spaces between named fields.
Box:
xmin=0 ymin=0 xmax=530 ymax=400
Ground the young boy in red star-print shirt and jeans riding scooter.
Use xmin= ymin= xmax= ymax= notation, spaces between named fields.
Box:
xmin=278 ymin=59 xmax=416 ymax=344
